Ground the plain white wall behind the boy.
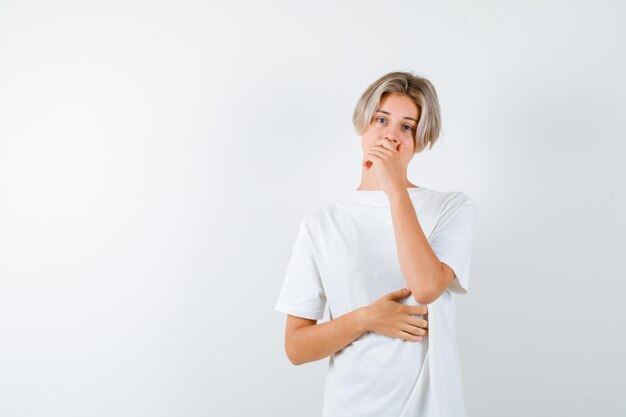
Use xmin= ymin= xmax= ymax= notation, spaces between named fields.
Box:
xmin=0 ymin=0 xmax=626 ymax=417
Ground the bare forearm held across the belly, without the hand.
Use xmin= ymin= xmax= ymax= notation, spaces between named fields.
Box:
xmin=289 ymin=308 xmax=365 ymax=365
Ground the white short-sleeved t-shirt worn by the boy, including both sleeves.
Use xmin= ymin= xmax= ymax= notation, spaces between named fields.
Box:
xmin=275 ymin=187 xmax=477 ymax=417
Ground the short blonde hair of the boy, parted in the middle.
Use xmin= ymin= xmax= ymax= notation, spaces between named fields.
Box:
xmin=352 ymin=71 xmax=441 ymax=153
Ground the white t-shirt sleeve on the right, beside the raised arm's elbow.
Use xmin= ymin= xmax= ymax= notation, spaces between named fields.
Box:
xmin=429 ymin=197 xmax=478 ymax=294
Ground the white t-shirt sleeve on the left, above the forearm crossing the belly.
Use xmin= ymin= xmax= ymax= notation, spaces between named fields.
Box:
xmin=274 ymin=223 xmax=326 ymax=320
